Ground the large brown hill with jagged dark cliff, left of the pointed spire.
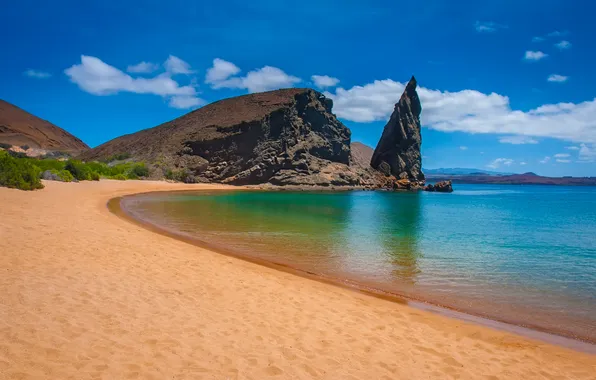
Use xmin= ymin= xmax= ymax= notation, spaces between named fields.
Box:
xmin=80 ymin=89 xmax=375 ymax=186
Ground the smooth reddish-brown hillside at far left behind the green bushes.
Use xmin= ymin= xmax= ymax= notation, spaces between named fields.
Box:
xmin=0 ymin=100 xmax=89 ymax=152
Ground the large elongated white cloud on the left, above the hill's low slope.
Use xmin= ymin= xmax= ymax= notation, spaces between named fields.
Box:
xmin=64 ymin=55 xmax=197 ymax=105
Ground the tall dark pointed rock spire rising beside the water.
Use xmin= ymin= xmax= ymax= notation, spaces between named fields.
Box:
xmin=370 ymin=77 xmax=424 ymax=184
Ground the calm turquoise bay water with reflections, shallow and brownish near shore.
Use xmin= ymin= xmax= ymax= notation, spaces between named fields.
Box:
xmin=123 ymin=185 xmax=596 ymax=342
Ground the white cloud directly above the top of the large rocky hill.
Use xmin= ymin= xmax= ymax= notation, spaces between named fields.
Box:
xmin=207 ymin=60 xmax=302 ymax=93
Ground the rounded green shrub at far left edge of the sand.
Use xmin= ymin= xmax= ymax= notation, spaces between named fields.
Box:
xmin=0 ymin=151 xmax=43 ymax=190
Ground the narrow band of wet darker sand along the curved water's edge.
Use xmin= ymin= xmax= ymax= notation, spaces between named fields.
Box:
xmin=116 ymin=187 xmax=596 ymax=354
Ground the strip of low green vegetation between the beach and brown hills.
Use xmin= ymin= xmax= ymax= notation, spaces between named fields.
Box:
xmin=0 ymin=150 xmax=150 ymax=190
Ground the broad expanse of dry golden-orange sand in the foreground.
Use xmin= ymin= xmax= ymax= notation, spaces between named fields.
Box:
xmin=0 ymin=181 xmax=596 ymax=380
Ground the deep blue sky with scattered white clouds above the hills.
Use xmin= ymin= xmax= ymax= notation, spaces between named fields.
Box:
xmin=0 ymin=0 xmax=596 ymax=176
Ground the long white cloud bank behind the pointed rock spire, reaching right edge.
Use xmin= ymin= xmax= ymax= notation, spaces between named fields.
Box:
xmin=325 ymin=79 xmax=596 ymax=143
